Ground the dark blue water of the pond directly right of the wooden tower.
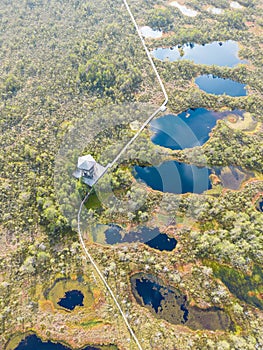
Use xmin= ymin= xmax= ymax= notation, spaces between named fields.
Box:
xmin=134 ymin=161 xmax=211 ymax=194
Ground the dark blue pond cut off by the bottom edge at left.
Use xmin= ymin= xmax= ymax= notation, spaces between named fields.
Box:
xmin=15 ymin=335 xmax=100 ymax=350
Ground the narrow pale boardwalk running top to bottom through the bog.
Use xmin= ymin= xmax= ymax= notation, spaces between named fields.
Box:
xmin=78 ymin=0 xmax=168 ymax=350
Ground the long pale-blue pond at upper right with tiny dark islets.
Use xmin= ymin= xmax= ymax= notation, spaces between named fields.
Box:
xmin=152 ymin=40 xmax=246 ymax=67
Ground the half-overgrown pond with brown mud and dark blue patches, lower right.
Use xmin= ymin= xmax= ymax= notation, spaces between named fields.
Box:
xmin=131 ymin=273 xmax=231 ymax=330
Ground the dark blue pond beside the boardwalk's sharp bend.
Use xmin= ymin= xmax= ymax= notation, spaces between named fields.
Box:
xmin=151 ymin=108 xmax=225 ymax=150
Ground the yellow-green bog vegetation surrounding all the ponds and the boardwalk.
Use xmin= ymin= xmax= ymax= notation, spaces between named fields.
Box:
xmin=0 ymin=0 xmax=263 ymax=350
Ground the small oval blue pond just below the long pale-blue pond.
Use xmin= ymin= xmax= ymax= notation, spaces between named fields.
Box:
xmin=195 ymin=74 xmax=247 ymax=97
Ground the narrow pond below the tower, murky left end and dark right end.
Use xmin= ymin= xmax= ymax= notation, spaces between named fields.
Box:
xmin=105 ymin=225 xmax=177 ymax=251
